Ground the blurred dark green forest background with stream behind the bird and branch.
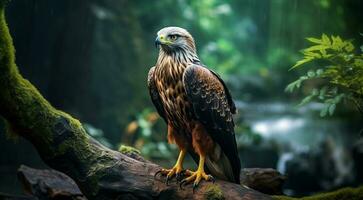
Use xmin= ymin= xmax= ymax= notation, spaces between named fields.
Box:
xmin=0 ymin=0 xmax=363 ymax=196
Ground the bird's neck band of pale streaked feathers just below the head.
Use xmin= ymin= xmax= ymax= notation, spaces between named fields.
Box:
xmin=156 ymin=49 xmax=200 ymax=66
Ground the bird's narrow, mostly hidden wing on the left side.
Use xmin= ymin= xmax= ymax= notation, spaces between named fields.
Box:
xmin=147 ymin=67 xmax=167 ymax=122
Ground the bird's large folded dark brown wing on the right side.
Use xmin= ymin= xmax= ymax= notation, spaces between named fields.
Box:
xmin=183 ymin=64 xmax=241 ymax=183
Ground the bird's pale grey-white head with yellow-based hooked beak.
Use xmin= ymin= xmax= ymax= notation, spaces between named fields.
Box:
xmin=155 ymin=27 xmax=195 ymax=53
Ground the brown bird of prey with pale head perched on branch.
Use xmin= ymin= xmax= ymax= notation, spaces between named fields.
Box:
xmin=148 ymin=27 xmax=241 ymax=188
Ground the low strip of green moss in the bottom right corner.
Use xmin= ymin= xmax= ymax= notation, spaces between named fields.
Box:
xmin=273 ymin=186 xmax=363 ymax=200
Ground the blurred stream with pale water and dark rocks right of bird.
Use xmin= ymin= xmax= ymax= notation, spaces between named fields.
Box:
xmin=236 ymin=102 xmax=358 ymax=196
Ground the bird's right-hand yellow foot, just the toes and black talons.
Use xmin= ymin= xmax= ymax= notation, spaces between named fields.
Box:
xmin=179 ymin=169 xmax=215 ymax=192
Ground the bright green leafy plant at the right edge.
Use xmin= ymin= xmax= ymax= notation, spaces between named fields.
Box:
xmin=285 ymin=34 xmax=363 ymax=117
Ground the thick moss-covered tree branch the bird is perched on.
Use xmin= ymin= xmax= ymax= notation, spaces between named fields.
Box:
xmin=0 ymin=0 xmax=282 ymax=200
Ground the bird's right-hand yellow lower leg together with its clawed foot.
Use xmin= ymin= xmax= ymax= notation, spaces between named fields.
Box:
xmin=180 ymin=155 xmax=214 ymax=191
